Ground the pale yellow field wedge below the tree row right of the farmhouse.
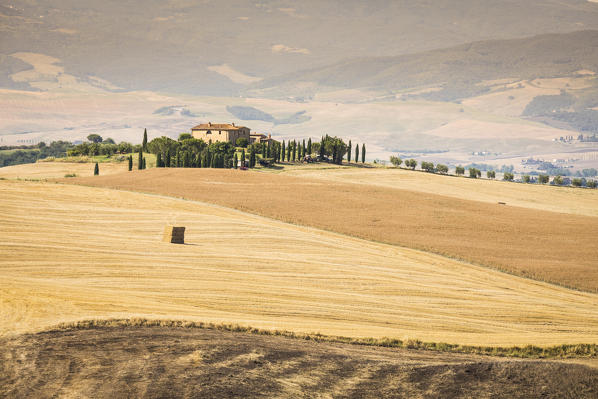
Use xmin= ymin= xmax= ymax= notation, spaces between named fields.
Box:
xmin=284 ymin=165 xmax=598 ymax=216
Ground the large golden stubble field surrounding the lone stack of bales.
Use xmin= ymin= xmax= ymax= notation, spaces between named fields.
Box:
xmin=0 ymin=181 xmax=598 ymax=346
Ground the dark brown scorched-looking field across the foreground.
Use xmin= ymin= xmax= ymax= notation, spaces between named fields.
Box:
xmin=0 ymin=327 xmax=598 ymax=399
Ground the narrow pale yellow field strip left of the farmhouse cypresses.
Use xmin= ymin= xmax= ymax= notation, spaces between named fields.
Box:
xmin=0 ymin=162 xmax=128 ymax=180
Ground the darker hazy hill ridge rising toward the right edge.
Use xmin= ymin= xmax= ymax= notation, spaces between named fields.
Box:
xmin=253 ymin=30 xmax=598 ymax=101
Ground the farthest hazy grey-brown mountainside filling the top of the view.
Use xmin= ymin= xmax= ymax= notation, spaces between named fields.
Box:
xmin=0 ymin=0 xmax=598 ymax=95
